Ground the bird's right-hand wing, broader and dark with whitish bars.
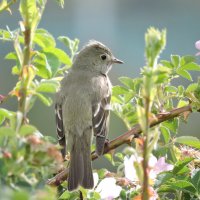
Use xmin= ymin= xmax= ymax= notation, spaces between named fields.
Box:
xmin=92 ymin=95 xmax=111 ymax=155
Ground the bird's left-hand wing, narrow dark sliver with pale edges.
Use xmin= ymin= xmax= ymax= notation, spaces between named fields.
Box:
xmin=55 ymin=104 xmax=66 ymax=158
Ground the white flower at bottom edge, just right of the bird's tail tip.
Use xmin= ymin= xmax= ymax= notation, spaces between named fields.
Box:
xmin=96 ymin=177 xmax=122 ymax=200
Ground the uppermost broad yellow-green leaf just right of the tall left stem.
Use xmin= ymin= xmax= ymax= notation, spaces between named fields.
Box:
xmin=33 ymin=29 xmax=56 ymax=49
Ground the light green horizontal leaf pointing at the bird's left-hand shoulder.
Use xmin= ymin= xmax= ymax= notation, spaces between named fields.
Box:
xmin=36 ymin=80 xmax=59 ymax=93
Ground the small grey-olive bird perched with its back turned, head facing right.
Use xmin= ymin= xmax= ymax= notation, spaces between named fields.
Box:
xmin=55 ymin=41 xmax=123 ymax=191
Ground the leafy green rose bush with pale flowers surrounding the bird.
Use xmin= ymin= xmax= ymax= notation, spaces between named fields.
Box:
xmin=0 ymin=0 xmax=200 ymax=200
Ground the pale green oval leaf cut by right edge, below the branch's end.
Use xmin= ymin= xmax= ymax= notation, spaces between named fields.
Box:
xmin=175 ymin=136 xmax=200 ymax=149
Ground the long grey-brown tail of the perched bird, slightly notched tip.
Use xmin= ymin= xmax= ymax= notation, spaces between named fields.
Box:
xmin=68 ymin=131 xmax=94 ymax=191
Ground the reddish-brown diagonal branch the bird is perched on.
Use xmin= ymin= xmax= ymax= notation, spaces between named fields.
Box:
xmin=47 ymin=105 xmax=192 ymax=186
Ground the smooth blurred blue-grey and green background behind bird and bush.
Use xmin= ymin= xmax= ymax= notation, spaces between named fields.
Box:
xmin=0 ymin=0 xmax=200 ymax=169
